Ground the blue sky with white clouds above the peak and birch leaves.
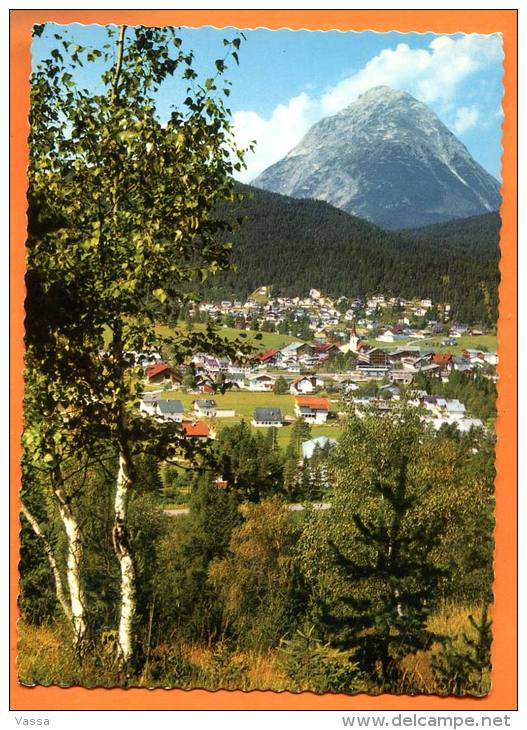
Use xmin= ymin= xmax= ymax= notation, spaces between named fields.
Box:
xmin=33 ymin=24 xmax=503 ymax=181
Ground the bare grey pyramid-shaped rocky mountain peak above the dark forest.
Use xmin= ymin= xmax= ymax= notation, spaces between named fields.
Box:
xmin=253 ymin=86 xmax=500 ymax=229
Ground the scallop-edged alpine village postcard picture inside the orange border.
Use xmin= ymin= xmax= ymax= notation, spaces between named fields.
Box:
xmin=16 ymin=15 xmax=516 ymax=698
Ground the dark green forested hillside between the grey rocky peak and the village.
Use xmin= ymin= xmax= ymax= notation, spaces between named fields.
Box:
xmin=206 ymin=186 xmax=499 ymax=323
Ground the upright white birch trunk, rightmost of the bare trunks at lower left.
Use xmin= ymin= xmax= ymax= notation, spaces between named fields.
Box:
xmin=113 ymin=451 xmax=136 ymax=667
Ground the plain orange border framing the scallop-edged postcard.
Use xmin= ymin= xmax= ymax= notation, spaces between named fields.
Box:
xmin=10 ymin=10 xmax=517 ymax=711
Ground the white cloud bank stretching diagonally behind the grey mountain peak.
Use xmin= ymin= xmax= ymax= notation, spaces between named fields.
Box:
xmin=234 ymin=34 xmax=503 ymax=181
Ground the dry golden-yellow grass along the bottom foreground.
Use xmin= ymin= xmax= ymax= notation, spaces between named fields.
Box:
xmin=18 ymin=604 xmax=490 ymax=694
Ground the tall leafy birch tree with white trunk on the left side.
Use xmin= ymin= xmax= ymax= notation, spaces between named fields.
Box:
xmin=25 ymin=21 xmax=251 ymax=671
